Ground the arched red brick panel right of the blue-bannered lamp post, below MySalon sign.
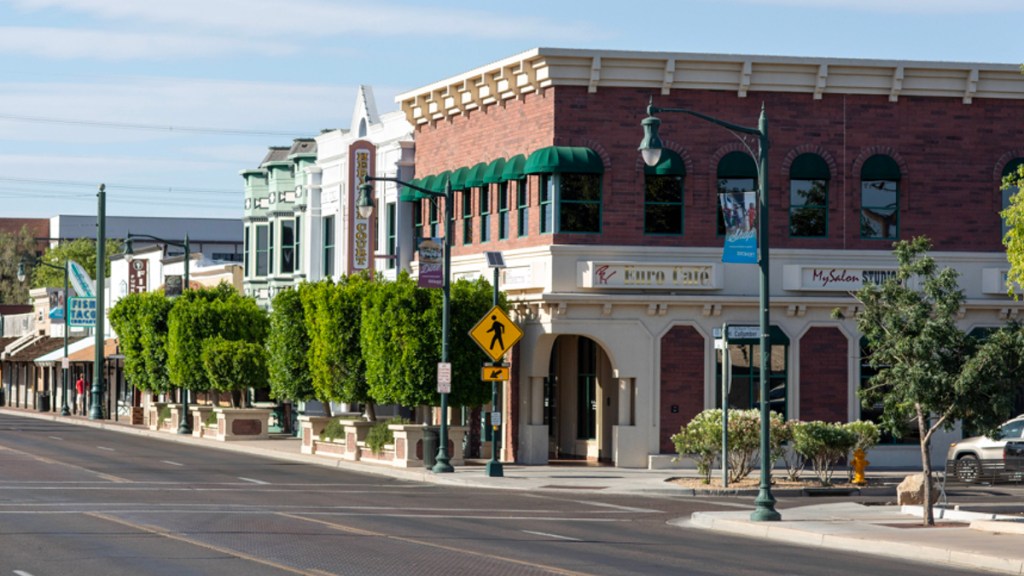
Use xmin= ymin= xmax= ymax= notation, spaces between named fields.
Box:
xmin=800 ymin=327 xmax=850 ymax=422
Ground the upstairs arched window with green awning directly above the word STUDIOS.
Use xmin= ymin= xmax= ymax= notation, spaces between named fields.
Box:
xmin=860 ymin=154 xmax=900 ymax=240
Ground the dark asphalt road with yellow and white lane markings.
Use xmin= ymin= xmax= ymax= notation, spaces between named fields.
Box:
xmin=0 ymin=414 xmax=991 ymax=576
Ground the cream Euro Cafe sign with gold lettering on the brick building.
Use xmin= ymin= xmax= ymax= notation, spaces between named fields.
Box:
xmin=577 ymin=261 xmax=722 ymax=290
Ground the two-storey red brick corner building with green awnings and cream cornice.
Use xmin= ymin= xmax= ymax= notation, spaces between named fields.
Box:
xmin=375 ymin=48 xmax=1024 ymax=467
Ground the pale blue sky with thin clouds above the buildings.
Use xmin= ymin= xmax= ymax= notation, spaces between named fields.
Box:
xmin=0 ymin=0 xmax=1024 ymax=218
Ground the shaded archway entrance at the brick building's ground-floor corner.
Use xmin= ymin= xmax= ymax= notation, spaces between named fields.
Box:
xmin=544 ymin=335 xmax=618 ymax=462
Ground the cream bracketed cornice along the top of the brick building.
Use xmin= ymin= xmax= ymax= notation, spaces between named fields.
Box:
xmin=395 ymin=48 xmax=1024 ymax=126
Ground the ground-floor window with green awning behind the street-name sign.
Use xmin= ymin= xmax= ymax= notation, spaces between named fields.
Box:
xmin=715 ymin=326 xmax=790 ymax=418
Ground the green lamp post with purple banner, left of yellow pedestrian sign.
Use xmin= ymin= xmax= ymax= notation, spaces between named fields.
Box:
xmin=357 ymin=175 xmax=455 ymax=472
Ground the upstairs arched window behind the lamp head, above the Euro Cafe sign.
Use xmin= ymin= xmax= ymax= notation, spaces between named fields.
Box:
xmin=643 ymin=149 xmax=686 ymax=236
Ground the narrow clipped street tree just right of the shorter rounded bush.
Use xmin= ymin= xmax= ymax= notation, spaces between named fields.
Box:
xmin=266 ymin=289 xmax=316 ymax=401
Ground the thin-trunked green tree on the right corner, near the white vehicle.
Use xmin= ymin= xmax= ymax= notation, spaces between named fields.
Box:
xmin=854 ymin=237 xmax=1024 ymax=526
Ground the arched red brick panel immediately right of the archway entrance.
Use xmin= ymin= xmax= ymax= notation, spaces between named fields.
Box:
xmin=658 ymin=326 xmax=705 ymax=453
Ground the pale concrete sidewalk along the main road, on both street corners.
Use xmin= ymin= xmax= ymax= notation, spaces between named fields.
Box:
xmin=8 ymin=408 xmax=1024 ymax=576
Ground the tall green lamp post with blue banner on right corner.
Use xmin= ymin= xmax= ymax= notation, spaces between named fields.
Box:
xmin=638 ymin=98 xmax=782 ymax=522
